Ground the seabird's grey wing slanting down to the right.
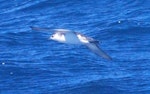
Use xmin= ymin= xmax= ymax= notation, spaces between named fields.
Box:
xmin=85 ymin=43 xmax=112 ymax=60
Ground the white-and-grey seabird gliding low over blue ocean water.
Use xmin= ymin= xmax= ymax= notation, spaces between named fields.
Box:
xmin=30 ymin=26 xmax=112 ymax=60
